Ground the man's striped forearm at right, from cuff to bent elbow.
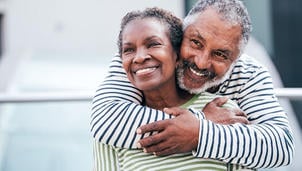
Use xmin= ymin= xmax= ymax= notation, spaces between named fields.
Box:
xmin=195 ymin=117 xmax=293 ymax=168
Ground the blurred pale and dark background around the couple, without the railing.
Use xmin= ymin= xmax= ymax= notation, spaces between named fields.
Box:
xmin=0 ymin=0 xmax=302 ymax=171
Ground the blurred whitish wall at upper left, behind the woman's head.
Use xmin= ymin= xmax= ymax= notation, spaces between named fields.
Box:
xmin=0 ymin=0 xmax=183 ymax=58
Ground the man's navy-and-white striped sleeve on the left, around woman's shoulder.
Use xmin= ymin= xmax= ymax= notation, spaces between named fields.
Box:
xmin=90 ymin=56 xmax=171 ymax=148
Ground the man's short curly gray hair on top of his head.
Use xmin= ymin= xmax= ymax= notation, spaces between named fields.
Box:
xmin=184 ymin=0 xmax=252 ymax=53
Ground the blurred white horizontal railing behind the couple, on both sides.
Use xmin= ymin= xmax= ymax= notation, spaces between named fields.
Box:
xmin=0 ymin=88 xmax=302 ymax=103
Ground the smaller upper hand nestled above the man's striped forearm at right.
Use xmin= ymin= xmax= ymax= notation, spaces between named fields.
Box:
xmin=202 ymin=97 xmax=249 ymax=125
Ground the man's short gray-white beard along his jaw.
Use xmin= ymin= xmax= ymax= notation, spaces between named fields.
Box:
xmin=176 ymin=62 xmax=236 ymax=94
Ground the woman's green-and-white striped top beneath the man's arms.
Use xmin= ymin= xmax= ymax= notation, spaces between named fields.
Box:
xmin=93 ymin=92 xmax=254 ymax=171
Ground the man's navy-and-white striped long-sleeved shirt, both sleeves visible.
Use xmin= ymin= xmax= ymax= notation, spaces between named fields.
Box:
xmin=91 ymin=55 xmax=294 ymax=168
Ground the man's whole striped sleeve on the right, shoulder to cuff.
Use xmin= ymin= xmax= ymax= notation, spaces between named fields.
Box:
xmin=194 ymin=55 xmax=294 ymax=168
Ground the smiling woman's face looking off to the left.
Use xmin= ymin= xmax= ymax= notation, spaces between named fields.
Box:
xmin=121 ymin=18 xmax=177 ymax=91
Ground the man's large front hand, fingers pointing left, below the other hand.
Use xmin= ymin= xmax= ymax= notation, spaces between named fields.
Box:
xmin=137 ymin=107 xmax=199 ymax=156
